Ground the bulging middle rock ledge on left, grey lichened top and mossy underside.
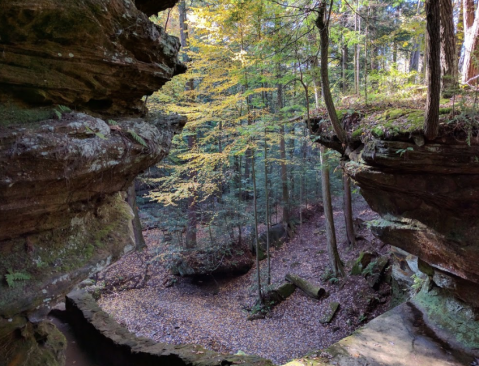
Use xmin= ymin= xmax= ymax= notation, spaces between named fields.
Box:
xmin=0 ymin=113 xmax=184 ymax=317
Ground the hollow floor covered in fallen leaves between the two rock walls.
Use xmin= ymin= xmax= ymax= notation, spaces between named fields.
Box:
xmin=99 ymin=196 xmax=390 ymax=364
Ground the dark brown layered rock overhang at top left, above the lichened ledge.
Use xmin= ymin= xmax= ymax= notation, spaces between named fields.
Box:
xmin=0 ymin=0 xmax=186 ymax=114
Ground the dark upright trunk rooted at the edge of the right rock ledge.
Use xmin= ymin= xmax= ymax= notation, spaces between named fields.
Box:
xmin=424 ymin=0 xmax=441 ymax=140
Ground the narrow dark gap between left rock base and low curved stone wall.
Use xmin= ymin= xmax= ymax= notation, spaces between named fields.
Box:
xmin=48 ymin=314 xmax=103 ymax=366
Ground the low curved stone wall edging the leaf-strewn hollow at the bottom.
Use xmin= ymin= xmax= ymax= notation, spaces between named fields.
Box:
xmin=66 ymin=291 xmax=273 ymax=366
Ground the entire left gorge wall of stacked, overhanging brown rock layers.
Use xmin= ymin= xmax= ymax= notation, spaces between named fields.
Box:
xmin=0 ymin=0 xmax=186 ymax=366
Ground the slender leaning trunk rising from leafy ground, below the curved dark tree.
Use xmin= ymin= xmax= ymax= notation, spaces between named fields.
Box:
xmin=320 ymin=145 xmax=344 ymax=276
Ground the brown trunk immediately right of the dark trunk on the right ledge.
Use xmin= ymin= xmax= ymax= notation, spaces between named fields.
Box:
xmin=440 ymin=0 xmax=457 ymax=98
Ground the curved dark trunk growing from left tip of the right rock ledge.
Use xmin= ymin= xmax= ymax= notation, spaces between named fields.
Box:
xmin=316 ymin=2 xmax=346 ymax=143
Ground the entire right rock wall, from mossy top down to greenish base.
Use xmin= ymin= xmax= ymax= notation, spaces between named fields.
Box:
xmin=313 ymin=109 xmax=479 ymax=357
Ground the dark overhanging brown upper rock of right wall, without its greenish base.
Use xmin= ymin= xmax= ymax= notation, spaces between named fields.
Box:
xmin=346 ymin=135 xmax=479 ymax=308
